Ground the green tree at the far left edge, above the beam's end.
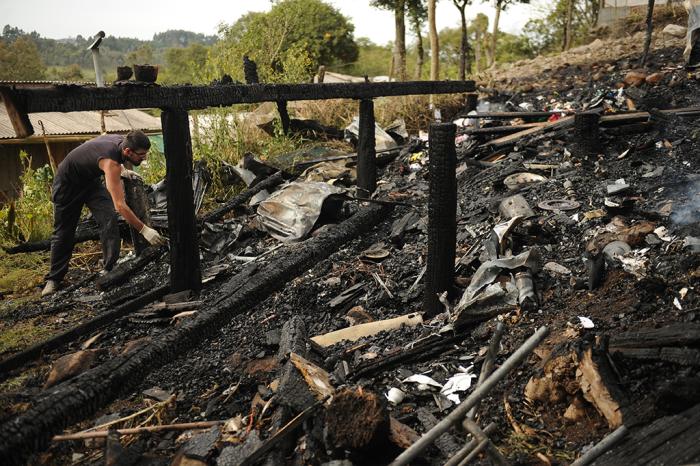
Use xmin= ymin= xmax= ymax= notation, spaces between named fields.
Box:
xmin=0 ymin=36 xmax=46 ymax=81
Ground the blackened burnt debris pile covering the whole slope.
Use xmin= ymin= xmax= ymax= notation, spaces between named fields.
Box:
xmin=0 ymin=43 xmax=700 ymax=465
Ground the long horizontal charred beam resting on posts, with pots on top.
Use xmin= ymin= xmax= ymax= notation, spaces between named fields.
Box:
xmin=0 ymin=81 xmax=475 ymax=113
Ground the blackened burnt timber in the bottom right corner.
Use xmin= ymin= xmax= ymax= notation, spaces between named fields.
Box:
xmin=593 ymin=404 xmax=700 ymax=466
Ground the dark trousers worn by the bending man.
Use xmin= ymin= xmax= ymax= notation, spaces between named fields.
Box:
xmin=46 ymin=179 xmax=121 ymax=282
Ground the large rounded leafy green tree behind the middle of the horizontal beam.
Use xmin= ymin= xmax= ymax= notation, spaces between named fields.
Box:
xmin=209 ymin=0 xmax=358 ymax=82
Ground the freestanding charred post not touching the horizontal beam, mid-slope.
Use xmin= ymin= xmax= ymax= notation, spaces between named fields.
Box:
xmin=423 ymin=123 xmax=457 ymax=316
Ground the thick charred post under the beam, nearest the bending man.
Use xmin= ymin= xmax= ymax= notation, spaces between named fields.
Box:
xmin=161 ymin=108 xmax=202 ymax=293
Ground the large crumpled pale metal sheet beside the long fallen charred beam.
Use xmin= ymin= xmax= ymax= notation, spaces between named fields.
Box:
xmin=258 ymin=182 xmax=344 ymax=242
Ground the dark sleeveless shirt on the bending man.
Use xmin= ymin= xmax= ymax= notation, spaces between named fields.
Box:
xmin=53 ymin=134 xmax=124 ymax=203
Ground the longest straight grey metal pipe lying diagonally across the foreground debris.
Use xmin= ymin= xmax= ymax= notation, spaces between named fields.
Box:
xmin=391 ymin=327 xmax=549 ymax=466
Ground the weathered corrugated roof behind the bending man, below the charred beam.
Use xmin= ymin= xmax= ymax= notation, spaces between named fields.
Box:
xmin=0 ymin=103 xmax=161 ymax=139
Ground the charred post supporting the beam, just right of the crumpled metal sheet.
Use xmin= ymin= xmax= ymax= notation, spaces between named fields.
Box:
xmin=357 ymin=99 xmax=377 ymax=198
